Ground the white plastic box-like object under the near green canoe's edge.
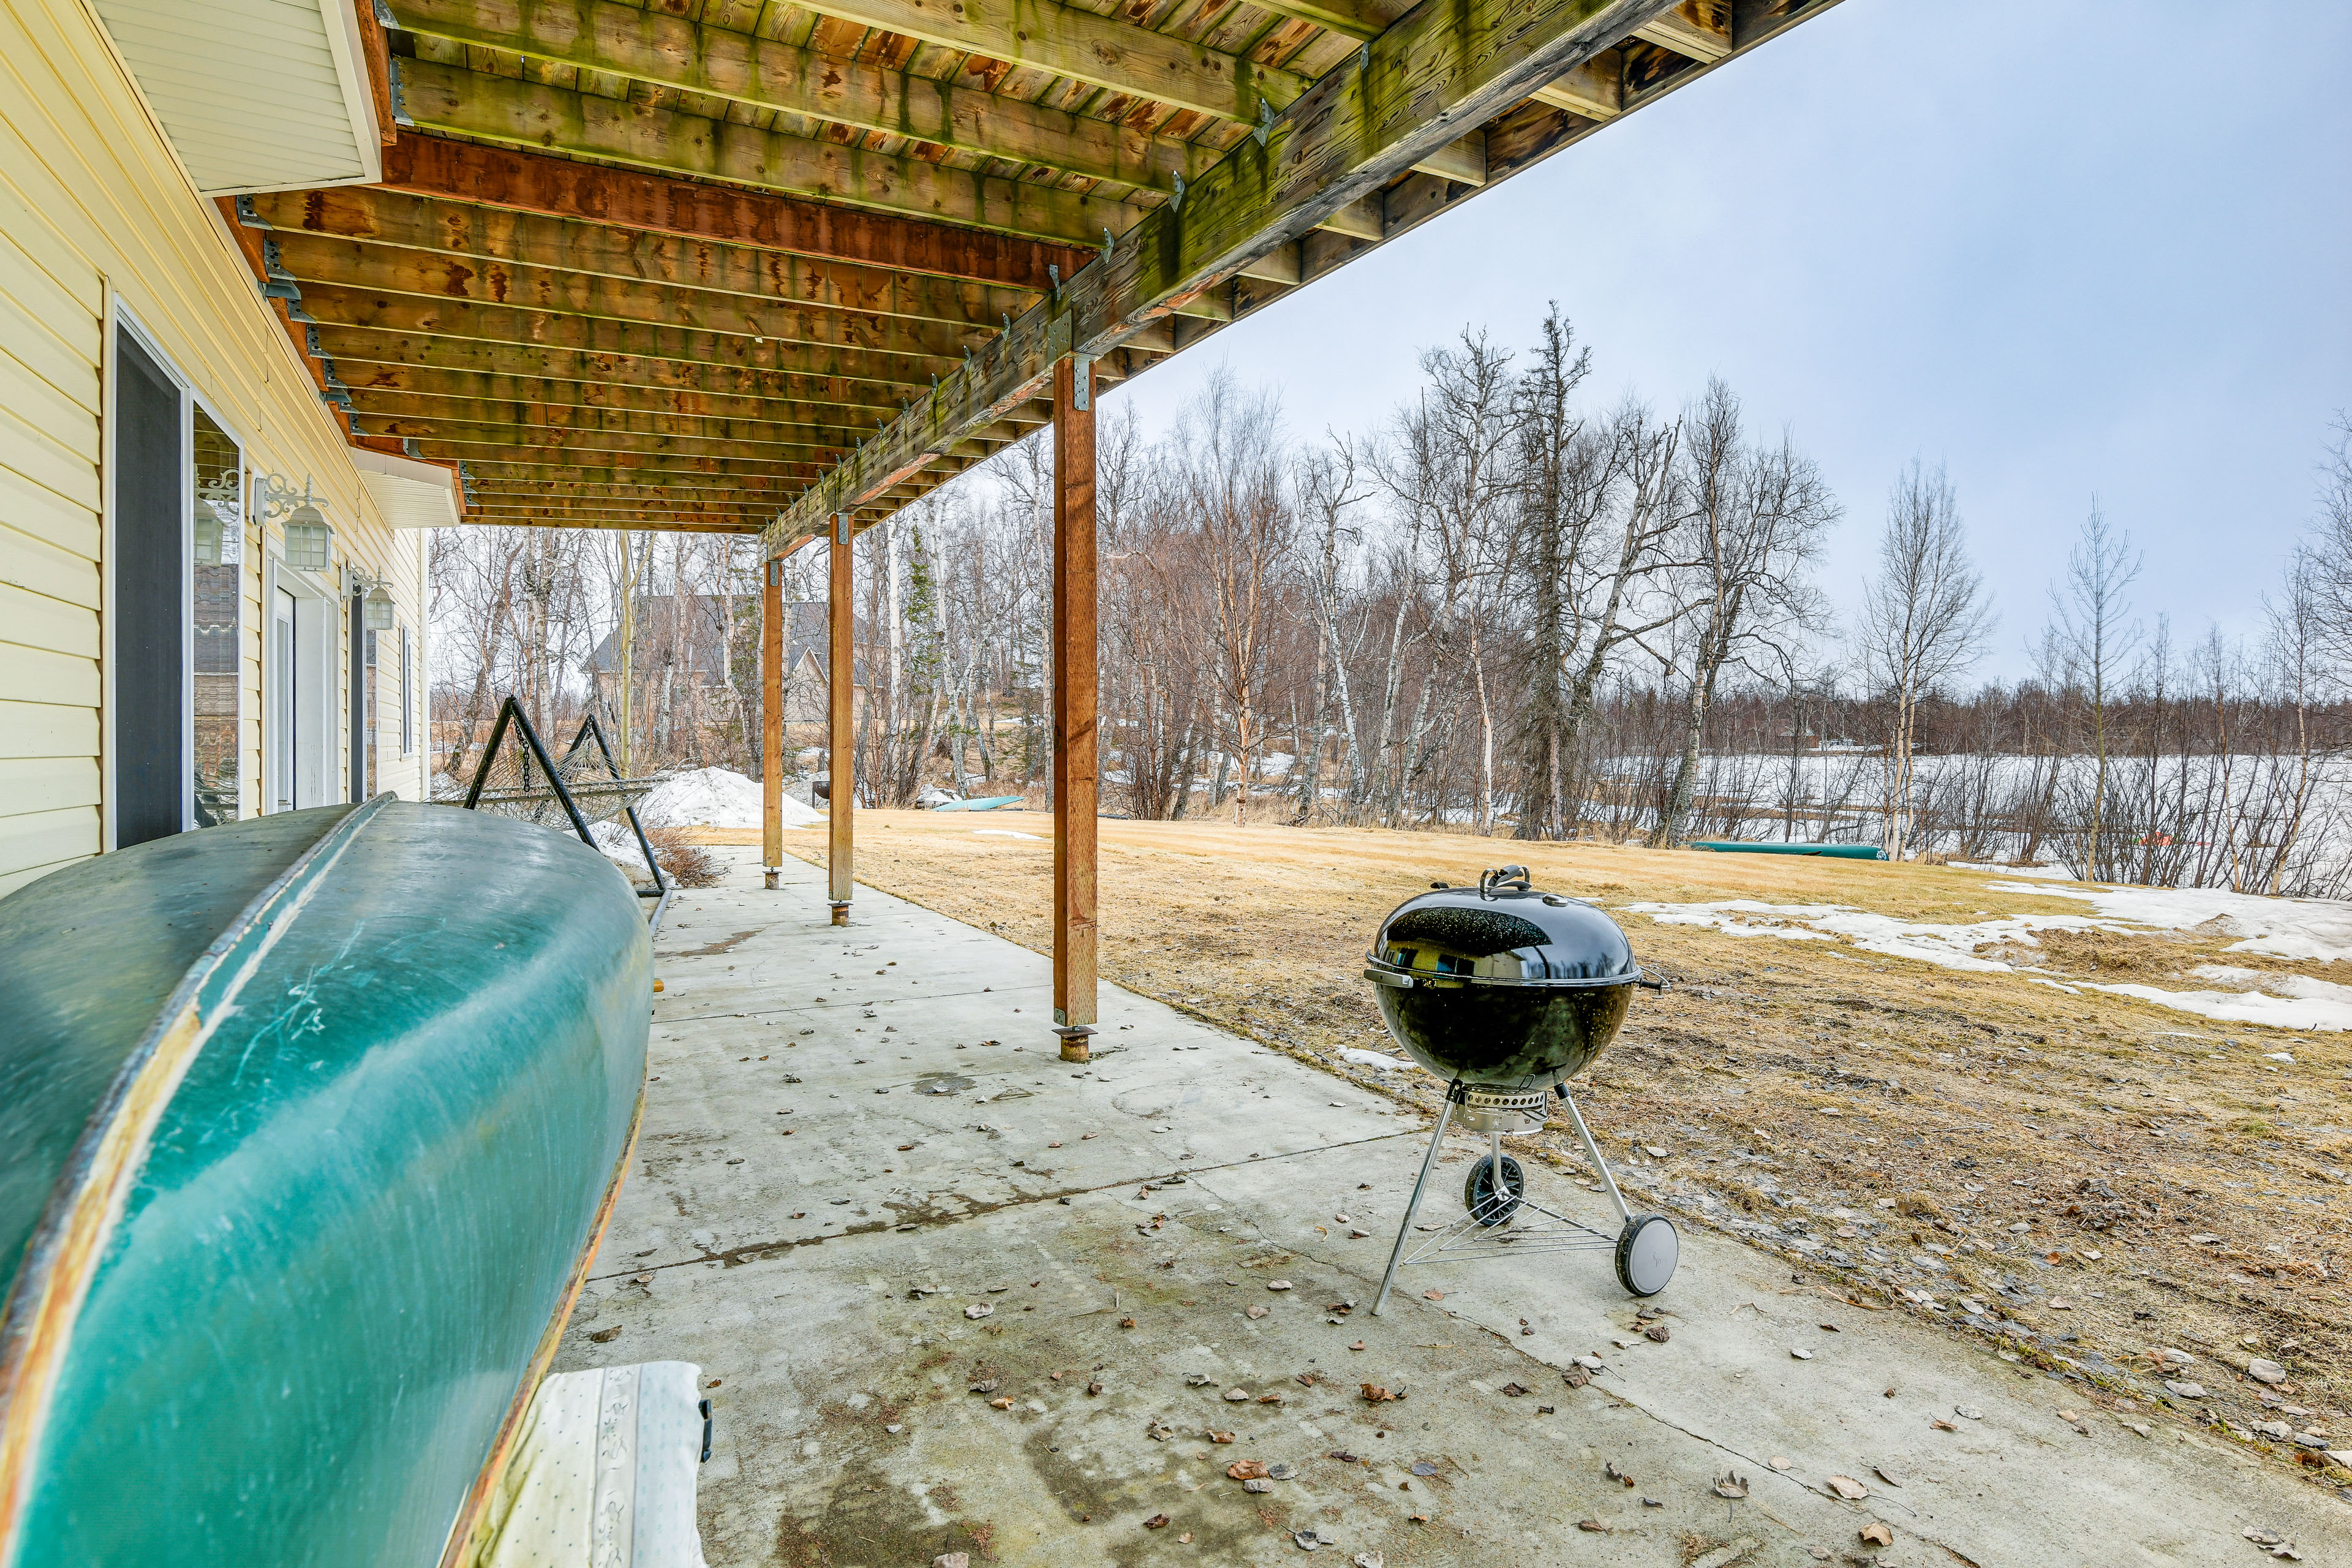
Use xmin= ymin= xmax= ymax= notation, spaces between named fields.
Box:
xmin=475 ymin=1361 xmax=703 ymax=1568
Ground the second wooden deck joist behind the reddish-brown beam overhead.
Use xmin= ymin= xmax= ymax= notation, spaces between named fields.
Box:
xmin=277 ymin=233 xmax=1011 ymax=357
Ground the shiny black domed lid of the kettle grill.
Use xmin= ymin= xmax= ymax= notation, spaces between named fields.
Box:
xmin=1366 ymin=865 xmax=1642 ymax=985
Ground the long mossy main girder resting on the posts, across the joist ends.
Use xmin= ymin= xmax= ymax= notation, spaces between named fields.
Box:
xmin=767 ymin=0 xmax=1712 ymax=550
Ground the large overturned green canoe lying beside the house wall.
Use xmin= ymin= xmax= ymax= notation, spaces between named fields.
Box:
xmin=0 ymin=797 xmax=652 ymax=1568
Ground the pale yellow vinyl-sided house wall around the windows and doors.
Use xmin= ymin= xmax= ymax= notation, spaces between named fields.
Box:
xmin=0 ymin=0 xmax=426 ymax=893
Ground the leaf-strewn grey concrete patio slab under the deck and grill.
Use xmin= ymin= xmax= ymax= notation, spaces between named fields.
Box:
xmin=557 ymin=851 xmax=2352 ymax=1568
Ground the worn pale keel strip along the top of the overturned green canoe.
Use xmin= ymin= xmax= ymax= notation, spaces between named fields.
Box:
xmin=0 ymin=792 xmax=395 ymax=1568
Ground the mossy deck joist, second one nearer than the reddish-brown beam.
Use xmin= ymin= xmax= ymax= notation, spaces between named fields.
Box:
xmin=381 ymin=0 xmax=1216 ymax=190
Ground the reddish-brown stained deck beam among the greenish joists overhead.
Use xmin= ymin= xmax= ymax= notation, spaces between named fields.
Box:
xmin=383 ymin=134 xmax=1098 ymax=294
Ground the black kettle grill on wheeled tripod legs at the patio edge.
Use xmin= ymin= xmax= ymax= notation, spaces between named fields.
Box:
xmin=1364 ymin=865 xmax=1682 ymax=1314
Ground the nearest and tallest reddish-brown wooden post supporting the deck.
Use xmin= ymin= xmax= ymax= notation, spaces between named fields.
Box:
xmin=1054 ymin=355 xmax=1098 ymax=1063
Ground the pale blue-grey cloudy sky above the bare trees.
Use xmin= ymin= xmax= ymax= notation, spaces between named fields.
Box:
xmin=1106 ymin=0 xmax=2352 ymax=679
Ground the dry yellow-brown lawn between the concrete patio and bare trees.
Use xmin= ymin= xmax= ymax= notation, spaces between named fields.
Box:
xmin=788 ymin=811 xmax=2352 ymax=1476
